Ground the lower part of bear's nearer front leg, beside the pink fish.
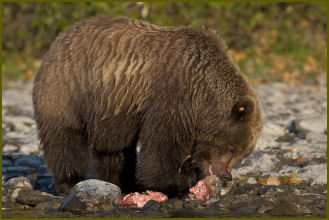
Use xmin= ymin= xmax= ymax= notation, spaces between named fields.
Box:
xmin=136 ymin=137 xmax=198 ymax=197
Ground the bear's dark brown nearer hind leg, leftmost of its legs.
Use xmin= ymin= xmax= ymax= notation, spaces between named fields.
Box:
xmin=40 ymin=127 xmax=91 ymax=194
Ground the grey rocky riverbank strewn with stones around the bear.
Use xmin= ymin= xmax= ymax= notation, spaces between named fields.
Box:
xmin=2 ymin=79 xmax=327 ymax=217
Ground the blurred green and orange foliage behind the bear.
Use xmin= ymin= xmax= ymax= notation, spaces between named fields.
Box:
xmin=2 ymin=2 xmax=327 ymax=88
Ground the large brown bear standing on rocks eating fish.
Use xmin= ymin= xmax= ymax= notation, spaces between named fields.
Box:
xmin=33 ymin=16 xmax=263 ymax=195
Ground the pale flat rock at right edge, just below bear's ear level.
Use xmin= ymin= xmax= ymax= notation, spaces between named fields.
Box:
xmin=295 ymin=115 xmax=327 ymax=133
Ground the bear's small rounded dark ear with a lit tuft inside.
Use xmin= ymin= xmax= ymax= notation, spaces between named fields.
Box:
xmin=232 ymin=98 xmax=254 ymax=120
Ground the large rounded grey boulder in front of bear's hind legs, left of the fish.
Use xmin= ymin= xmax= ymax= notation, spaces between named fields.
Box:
xmin=61 ymin=179 xmax=121 ymax=213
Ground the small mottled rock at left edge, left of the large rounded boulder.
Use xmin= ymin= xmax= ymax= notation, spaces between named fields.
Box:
xmin=3 ymin=176 xmax=33 ymax=200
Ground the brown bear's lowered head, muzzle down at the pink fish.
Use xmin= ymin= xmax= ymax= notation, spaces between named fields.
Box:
xmin=191 ymin=71 xmax=263 ymax=185
